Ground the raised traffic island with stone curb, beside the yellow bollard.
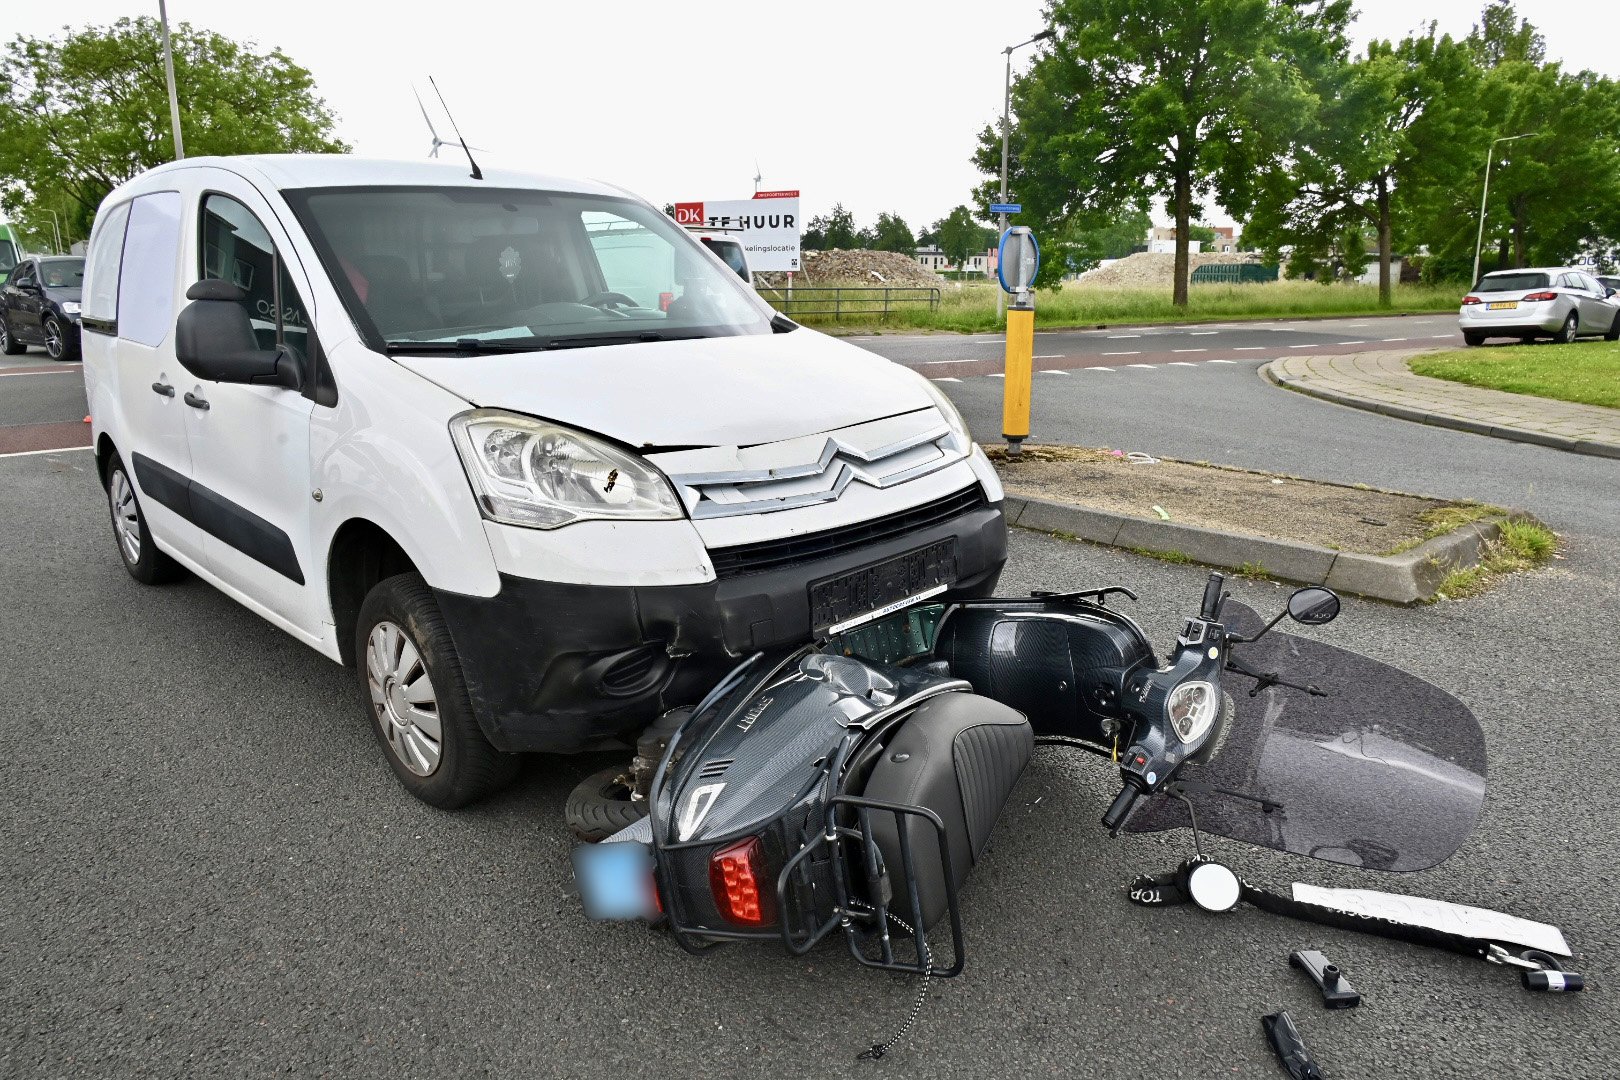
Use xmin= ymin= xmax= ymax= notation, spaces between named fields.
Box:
xmin=987 ymin=445 xmax=1557 ymax=604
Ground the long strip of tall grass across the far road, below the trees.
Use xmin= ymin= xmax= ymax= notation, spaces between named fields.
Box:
xmin=773 ymin=282 xmax=1461 ymax=332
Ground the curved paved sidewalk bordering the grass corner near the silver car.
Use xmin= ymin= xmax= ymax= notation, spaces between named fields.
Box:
xmin=1260 ymin=350 xmax=1620 ymax=458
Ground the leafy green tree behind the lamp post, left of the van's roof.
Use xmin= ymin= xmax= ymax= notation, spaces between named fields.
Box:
xmin=0 ymin=16 xmax=348 ymax=244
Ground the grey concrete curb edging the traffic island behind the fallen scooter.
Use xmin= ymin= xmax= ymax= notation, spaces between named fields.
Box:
xmin=1003 ymin=492 xmax=1528 ymax=604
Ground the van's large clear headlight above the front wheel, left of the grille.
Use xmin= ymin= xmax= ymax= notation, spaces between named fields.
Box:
xmin=450 ymin=410 xmax=685 ymax=529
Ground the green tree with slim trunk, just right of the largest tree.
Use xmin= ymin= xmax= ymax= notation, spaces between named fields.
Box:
xmin=1249 ymin=24 xmax=1479 ymax=306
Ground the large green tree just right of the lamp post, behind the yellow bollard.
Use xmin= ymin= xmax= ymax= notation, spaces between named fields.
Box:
xmin=974 ymin=0 xmax=1349 ymax=306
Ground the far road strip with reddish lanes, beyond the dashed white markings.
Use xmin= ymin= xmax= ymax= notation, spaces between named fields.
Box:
xmin=847 ymin=314 xmax=1463 ymax=382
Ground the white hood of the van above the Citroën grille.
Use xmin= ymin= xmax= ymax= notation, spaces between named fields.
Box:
xmin=394 ymin=329 xmax=933 ymax=447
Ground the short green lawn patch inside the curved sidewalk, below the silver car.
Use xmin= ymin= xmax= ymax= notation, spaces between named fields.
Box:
xmin=1411 ymin=342 xmax=1620 ymax=408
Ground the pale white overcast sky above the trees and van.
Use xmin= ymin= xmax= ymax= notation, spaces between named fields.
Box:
xmin=12 ymin=0 xmax=1620 ymax=228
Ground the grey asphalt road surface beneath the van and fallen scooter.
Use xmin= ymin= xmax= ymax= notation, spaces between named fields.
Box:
xmin=0 ymin=325 xmax=1620 ymax=1077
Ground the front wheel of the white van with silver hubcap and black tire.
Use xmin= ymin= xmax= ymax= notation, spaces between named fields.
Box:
xmin=355 ymin=573 xmax=520 ymax=810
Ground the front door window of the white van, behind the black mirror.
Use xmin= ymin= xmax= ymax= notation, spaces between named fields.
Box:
xmin=201 ymin=194 xmax=309 ymax=361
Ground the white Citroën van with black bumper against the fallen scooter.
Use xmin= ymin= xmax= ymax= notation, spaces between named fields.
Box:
xmin=83 ymin=155 xmax=1006 ymax=808
